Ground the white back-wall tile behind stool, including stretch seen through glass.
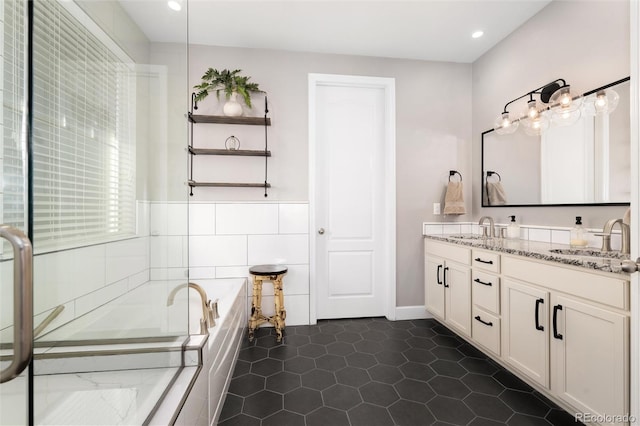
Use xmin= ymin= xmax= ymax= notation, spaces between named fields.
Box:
xmin=150 ymin=202 xmax=309 ymax=325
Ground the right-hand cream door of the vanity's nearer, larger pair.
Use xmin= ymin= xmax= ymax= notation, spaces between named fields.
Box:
xmin=551 ymin=295 xmax=629 ymax=416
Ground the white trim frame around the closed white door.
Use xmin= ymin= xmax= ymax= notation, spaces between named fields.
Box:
xmin=308 ymin=73 xmax=396 ymax=324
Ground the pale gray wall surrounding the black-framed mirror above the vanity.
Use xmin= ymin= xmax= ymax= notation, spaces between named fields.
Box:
xmin=473 ymin=0 xmax=630 ymax=228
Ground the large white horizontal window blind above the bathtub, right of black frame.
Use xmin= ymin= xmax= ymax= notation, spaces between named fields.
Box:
xmin=18 ymin=1 xmax=136 ymax=252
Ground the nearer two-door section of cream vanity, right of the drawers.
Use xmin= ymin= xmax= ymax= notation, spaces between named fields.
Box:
xmin=502 ymin=256 xmax=629 ymax=418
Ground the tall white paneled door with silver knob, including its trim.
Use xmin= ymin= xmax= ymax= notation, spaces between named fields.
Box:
xmin=310 ymin=77 xmax=395 ymax=319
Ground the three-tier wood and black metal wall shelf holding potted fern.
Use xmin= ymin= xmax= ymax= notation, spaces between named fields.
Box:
xmin=187 ymin=93 xmax=271 ymax=197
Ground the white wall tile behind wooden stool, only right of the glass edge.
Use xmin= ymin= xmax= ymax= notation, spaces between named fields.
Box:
xmin=186 ymin=203 xmax=309 ymax=325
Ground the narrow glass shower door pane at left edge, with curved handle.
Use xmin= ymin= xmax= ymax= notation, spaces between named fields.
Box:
xmin=0 ymin=0 xmax=30 ymax=425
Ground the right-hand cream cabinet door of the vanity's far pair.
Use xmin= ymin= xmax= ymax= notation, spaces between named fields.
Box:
xmin=442 ymin=261 xmax=471 ymax=336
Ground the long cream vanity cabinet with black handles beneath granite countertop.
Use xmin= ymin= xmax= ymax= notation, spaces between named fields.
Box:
xmin=425 ymin=238 xmax=630 ymax=424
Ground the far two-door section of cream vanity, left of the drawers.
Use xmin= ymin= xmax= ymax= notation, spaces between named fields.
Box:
xmin=425 ymin=239 xmax=471 ymax=336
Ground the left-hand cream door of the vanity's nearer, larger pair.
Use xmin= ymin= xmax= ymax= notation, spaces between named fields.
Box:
xmin=502 ymin=279 xmax=549 ymax=388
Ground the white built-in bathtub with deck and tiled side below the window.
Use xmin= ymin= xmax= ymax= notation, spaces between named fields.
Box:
xmin=0 ymin=278 xmax=247 ymax=425
